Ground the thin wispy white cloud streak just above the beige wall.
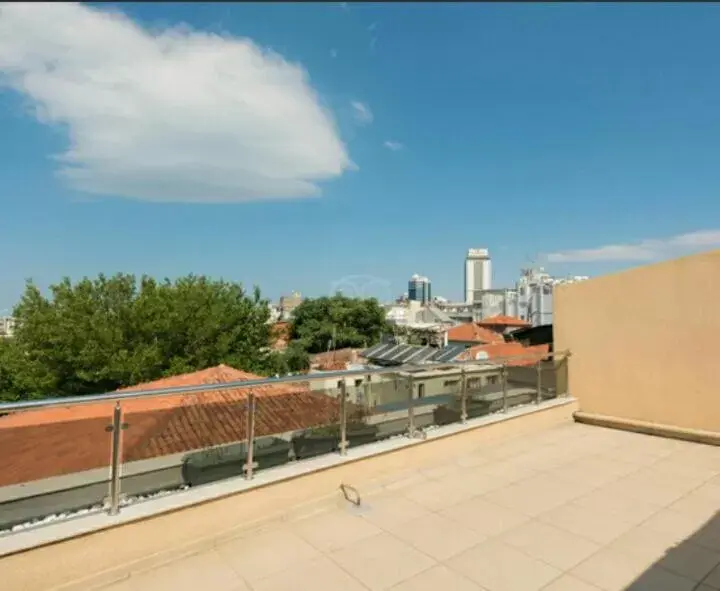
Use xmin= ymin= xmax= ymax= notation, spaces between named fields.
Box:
xmin=546 ymin=230 xmax=720 ymax=263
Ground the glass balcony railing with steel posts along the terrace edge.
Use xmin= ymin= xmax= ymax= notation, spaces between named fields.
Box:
xmin=0 ymin=352 xmax=570 ymax=535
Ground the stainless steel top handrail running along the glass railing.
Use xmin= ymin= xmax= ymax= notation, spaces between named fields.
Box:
xmin=0 ymin=351 xmax=570 ymax=420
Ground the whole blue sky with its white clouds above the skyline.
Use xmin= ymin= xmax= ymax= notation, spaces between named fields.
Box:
xmin=0 ymin=3 xmax=720 ymax=310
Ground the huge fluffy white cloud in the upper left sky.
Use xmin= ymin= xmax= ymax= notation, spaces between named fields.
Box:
xmin=0 ymin=3 xmax=353 ymax=202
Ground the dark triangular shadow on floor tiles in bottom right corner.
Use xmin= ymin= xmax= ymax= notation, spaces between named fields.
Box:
xmin=625 ymin=506 xmax=720 ymax=591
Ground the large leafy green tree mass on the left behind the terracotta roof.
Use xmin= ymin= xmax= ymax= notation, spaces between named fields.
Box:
xmin=6 ymin=274 xmax=275 ymax=398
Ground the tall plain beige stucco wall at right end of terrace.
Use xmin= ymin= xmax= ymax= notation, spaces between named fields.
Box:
xmin=553 ymin=250 xmax=720 ymax=432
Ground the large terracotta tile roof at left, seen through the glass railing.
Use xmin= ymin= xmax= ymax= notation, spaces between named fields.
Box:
xmin=0 ymin=365 xmax=339 ymax=486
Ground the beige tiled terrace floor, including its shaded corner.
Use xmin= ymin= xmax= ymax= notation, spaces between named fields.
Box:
xmin=100 ymin=424 xmax=720 ymax=591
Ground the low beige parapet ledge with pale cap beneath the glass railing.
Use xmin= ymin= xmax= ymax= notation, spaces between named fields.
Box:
xmin=0 ymin=397 xmax=576 ymax=591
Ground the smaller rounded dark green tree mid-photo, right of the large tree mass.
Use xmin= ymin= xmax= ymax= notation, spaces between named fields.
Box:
xmin=292 ymin=295 xmax=388 ymax=353
